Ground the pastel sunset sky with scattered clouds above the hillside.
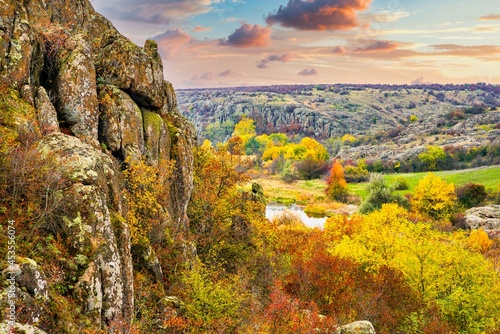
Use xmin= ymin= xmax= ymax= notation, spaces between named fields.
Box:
xmin=92 ymin=0 xmax=500 ymax=89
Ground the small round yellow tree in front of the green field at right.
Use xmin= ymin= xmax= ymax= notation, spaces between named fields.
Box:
xmin=412 ymin=173 xmax=456 ymax=220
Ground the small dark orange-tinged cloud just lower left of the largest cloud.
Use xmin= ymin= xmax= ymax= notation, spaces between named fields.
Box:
xmin=219 ymin=23 xmax=271 ymax=48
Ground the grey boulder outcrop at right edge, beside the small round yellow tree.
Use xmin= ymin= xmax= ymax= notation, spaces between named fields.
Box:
xmin=465 ymin=205 xmax=500 ymax=238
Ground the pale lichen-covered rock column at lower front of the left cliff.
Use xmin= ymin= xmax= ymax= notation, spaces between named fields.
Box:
xmin=39 ymin=133 xmax=133 ymax=321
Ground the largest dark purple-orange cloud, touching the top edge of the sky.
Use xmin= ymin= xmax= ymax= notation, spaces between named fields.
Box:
xmin=266 ymin=0 xmax=372 ymax=30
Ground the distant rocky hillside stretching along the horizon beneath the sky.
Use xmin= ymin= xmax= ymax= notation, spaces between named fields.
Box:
xmin=178 ymin=84 xmax=500 ymax=160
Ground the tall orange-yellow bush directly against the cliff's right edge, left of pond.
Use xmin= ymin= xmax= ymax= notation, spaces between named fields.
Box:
xmin=188 ymin=144 xmax=263 ymax=270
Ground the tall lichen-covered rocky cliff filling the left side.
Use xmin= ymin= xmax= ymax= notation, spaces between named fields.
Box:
xmin=0 ymin=0 xmax=196 ymax=333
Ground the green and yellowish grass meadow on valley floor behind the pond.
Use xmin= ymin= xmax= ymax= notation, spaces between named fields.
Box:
xmin=255 ymin=166 xmax=500 ymax=205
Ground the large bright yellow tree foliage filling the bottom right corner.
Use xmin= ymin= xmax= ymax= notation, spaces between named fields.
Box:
xmin=326 ymin=204 xmax=500 ymax=333
